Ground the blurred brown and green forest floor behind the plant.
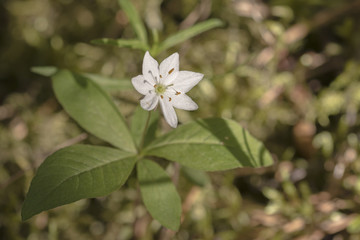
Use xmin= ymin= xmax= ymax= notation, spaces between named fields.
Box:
xmin=0 ymin=0 xmax=360 ymax=240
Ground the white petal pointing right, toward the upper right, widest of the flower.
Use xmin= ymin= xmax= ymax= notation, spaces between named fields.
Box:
xmin=173 ymin=71 xmax=204 ymax=93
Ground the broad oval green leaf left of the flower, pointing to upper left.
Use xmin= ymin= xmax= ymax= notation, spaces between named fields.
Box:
xmin=52 ymin=70 xmax=136 ymax=152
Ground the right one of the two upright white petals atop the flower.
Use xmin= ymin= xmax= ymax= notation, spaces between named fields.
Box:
xmin=160 ymin=53 xmax=179 ymax=85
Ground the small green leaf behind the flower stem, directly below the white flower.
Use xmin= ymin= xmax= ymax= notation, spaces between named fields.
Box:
xmin=131 ymin=106 xmax=159 ymax=146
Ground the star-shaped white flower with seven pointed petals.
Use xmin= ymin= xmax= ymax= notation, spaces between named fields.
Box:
xmin=131 ymin=52 xmax=204 ymax=128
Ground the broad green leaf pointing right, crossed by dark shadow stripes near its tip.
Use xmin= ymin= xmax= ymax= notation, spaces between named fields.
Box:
xmin=144 ymin=118 xmax=273 ymax=171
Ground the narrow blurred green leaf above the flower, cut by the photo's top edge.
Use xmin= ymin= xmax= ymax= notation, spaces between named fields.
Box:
xmin=118 ymin=0 xmax=148 ymax=44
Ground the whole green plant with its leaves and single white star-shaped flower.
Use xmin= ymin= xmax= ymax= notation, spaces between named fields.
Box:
xmin=22 ymin=0 xmax=272 ymax=230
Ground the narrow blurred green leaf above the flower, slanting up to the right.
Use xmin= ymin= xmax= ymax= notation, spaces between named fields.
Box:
xmin=154 ymin=19 xmax=223 ymax=55
